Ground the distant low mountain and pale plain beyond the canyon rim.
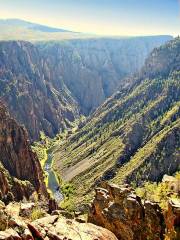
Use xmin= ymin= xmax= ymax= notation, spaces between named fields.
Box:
xmin=0 ymin=19 xmax=172 ymax=42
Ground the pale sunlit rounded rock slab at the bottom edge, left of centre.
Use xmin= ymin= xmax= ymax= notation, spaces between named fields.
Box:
xmin=28 ymin=216 xmax=117 ymax=240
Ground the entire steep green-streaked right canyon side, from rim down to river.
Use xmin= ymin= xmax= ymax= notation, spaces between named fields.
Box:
xmin=54 ymin=38 xmax=180 ymax=203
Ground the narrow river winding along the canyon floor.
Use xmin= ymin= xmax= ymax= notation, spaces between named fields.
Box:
xmin=44 ymin=153 xmax=63 ymax=203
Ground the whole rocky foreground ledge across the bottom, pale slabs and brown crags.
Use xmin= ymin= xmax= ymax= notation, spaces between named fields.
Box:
xmin=0 ymin=183 xmax=180 ymax=240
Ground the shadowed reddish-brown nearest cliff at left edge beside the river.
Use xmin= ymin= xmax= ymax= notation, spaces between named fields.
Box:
xmin=0 ymin=102 xmax=47 ymax=200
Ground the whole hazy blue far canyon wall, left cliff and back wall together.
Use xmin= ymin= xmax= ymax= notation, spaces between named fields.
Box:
xmin=0 ymin=36 xmax=171 ymax=140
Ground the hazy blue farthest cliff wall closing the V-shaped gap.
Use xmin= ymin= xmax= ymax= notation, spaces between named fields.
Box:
xmin=38 ymin=36 xmax=170 ymax=115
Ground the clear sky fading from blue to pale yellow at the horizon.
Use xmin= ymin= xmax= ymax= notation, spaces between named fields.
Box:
xmin=0 ymin=0 xmax=180 ymax=36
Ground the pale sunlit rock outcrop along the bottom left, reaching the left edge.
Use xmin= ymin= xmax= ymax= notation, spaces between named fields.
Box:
xmin=0 ymin=206 xmax=117 ymax=240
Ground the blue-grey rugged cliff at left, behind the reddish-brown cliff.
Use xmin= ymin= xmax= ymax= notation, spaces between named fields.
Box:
xmin=0 ymin=42 xmax=78 ymax=140
